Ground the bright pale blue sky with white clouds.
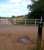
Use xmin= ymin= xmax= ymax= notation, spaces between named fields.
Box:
xmin=0 ymin=0 xmax=32 ymax=17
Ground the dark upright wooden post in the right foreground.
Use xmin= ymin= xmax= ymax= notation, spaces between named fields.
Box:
xmin=37 ymin=17 xmax=43 ymax=50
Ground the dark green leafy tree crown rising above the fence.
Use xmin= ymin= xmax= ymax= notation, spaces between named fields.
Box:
xmin=27 ymin=0 xmax=44 ymax=19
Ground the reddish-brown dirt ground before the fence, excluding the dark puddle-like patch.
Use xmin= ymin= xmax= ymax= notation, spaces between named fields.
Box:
xmin=0 ymin=25 xmax=44 ymax=50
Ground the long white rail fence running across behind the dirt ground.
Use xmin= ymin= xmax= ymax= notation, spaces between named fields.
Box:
xmin=0 ymin=19 xmax=44 ymax=25
